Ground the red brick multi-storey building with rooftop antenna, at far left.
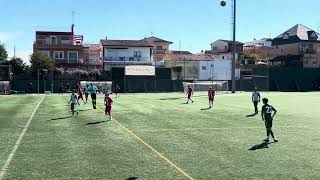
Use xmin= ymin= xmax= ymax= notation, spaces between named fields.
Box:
xmin=33 ymin=26 xmax=84 ymax=68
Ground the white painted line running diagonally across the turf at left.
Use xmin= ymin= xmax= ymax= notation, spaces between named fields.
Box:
xmin=0 ymin=96 xmax=45 ymax=180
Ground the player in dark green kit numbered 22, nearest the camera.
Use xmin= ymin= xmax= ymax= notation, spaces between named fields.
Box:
xmin=261 ymin=98 xmax=278 ymax=142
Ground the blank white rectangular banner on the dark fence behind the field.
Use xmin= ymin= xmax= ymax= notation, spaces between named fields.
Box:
xmin=125 ymin=66 xmax=156 ymax=76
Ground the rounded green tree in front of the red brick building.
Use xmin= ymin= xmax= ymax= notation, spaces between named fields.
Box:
xmin=30 ymin=52 xmax=55 ymax=72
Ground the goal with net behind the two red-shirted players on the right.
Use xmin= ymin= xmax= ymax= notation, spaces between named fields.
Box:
xmin=183 ymin=81 xmax=228 ymax=93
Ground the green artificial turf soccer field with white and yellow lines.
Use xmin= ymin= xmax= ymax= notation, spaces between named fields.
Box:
xmin=0 ymin=93 xmax=320 ymax=180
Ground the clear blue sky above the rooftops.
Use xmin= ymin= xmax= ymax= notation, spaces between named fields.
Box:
xmin=0 ymin=0 xmax=320 ymax=63
